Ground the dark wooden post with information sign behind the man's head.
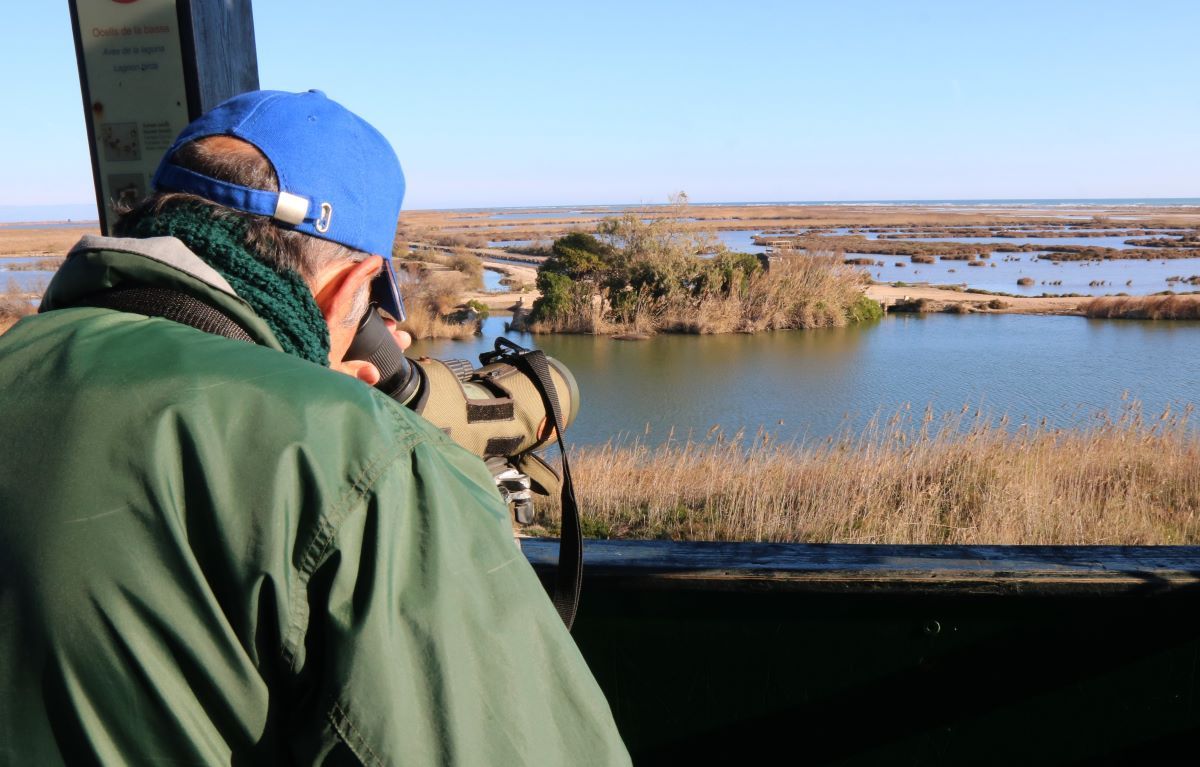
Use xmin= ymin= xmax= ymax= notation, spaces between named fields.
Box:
xmin=68 ymin=0 xmax=258 ymax=234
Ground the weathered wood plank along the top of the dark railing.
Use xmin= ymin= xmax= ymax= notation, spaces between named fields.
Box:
xmin=522 ymin=539 xmax=1200 ymax=595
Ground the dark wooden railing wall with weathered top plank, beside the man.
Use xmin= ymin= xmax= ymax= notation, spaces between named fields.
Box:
xmin=523 ymin=540 xmax=1200 ymax=765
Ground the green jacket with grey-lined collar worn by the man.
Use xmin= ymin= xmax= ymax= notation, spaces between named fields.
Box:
xmin=0 ymin=238 xmax=628 ymax=765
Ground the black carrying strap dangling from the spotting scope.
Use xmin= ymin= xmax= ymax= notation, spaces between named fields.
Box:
xmin=480 ymin=338 xmax=583 ymax=630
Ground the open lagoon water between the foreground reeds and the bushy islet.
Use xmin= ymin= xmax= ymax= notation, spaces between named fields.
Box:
xmin=410 ymin=314 xmax=1200 ymax=444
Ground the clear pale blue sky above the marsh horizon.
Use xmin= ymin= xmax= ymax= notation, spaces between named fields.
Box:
xmin=0 ymin=0 xmax=1200 ymax=213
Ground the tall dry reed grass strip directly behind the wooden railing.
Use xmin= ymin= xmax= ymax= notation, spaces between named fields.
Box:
xmin=540 ymin=405 xmax=1200 ymax=545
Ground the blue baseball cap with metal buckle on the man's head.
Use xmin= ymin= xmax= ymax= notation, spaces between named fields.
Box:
xmin=152 ymin=90 xmax=404 ymax=319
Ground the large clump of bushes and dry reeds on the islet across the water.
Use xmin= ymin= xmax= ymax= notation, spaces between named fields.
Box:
xmin=529 ymin=198 xmax=883 ymax=332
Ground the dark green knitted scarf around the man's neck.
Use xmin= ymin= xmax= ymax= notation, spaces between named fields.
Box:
xmin=121 ymin=204 xmax=329 ymax=367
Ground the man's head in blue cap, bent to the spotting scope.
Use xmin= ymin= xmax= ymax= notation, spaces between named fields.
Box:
xmin=118 ymin=91 xmax=404 ymax=379
